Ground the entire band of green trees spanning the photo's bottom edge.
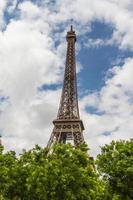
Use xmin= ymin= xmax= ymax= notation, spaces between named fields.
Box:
xmin=0 ymin=140 xmax=133 ymax=200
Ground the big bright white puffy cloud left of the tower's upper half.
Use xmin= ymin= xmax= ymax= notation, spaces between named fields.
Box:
xmin=0 ymin=17 xmax=60 ymax=100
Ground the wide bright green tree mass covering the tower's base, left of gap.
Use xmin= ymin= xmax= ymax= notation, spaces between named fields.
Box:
xmin=0 ymin=144 xmax=105 ymax=200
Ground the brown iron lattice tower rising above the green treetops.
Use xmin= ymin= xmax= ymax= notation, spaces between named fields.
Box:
xmin=47 ymin=26 xmax=84 ymax=148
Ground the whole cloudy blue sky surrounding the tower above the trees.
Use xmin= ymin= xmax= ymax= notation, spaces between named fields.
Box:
xmin=0 ymin=0 xmax=133 ymax=156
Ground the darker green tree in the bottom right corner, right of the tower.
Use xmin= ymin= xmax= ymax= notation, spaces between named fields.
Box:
xmin=97 ymin=139 xmax=133 ymax=200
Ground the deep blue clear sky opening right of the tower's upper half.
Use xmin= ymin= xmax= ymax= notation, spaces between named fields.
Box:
xmin=77 ymin=21 xmax=133 ymax=92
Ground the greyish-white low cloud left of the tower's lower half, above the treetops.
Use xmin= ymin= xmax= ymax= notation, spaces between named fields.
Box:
xmin=1 ymin=91 xmax=60 ymax=152
